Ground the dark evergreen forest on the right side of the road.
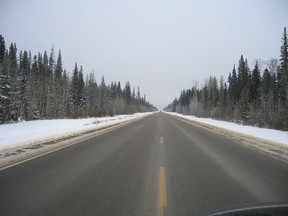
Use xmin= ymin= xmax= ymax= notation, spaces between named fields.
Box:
xmin=165 ymin=28 xmax=288 ymax=130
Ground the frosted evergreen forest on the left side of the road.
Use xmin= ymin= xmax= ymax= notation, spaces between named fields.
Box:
xmin=0 ymin=35 xmax=156 ymax=124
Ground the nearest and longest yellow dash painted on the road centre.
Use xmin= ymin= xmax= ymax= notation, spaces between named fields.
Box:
xmin=157 ymin=167 xmax=167 ymax=216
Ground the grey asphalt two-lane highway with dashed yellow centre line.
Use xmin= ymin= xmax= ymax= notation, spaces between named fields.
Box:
xmin=0 ymin=112 xmax=288 ymax=216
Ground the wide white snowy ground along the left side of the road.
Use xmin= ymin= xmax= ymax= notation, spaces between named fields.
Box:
xmin=0 ymin=113 xmax=151 ymax=150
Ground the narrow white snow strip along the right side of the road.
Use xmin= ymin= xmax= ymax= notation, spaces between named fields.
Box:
xmin=168 ymin=112 xmax=288 ymax=145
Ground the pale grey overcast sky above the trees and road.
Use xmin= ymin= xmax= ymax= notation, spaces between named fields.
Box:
xmin=0 ymin=0 xmax=288 ymax=109
